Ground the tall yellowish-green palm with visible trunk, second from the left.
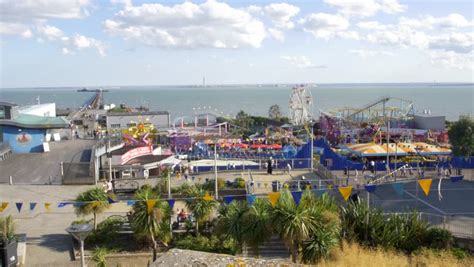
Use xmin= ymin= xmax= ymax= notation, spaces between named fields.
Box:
xmin=130 ymin=187 xmax=171 ymax=261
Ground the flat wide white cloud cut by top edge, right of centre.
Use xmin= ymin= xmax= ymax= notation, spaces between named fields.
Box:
xmin=324 ymin=0 xmax=406 ymax=17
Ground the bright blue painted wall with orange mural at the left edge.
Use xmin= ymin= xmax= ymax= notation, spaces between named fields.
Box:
xmin=3 ymin=126 xmax=46 ymax=153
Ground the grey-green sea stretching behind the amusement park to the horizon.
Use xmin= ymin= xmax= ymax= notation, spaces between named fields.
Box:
xmin=0 ymin=83 xmax=474 ymax=120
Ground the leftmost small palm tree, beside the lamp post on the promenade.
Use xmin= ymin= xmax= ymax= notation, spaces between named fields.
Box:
xmin=74 ymin=187 xmax=110 ymax=230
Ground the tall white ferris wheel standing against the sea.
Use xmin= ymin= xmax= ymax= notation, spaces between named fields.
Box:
xmin=289 ymin=85 xmax=313 ymax=125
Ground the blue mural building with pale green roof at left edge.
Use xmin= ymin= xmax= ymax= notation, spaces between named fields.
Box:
xmin=0 ymin=102 xmax=69 ymax=153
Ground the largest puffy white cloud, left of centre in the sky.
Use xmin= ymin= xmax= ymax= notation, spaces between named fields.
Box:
xmin=104 ymin=1 xmax=266 ymax=48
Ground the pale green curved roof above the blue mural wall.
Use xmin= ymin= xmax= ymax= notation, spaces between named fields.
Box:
xmin=0 ymin=114 xmax=69 ymax=129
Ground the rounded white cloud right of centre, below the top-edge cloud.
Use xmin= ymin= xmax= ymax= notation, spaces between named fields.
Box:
xmin=298 ymin=13 xmax=349 ymax=40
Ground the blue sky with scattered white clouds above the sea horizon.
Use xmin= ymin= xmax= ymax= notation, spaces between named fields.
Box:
xmin=0 ymin=0 xmax=474 ymax=88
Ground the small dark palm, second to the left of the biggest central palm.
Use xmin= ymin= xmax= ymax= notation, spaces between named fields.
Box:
xmin=217 ymin=201 xmax=249 ymax=253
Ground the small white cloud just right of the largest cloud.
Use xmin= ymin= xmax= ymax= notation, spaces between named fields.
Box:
xmin=264 ymin=3 xmax=300 ymax=29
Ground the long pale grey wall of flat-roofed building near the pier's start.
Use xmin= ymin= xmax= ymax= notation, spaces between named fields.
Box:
xmin=107 ymin=114 xmax=170 ymax=129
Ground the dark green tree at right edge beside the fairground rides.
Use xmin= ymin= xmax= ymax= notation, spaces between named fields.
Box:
xmin=448 ymin=116 xmax=474 ymax=157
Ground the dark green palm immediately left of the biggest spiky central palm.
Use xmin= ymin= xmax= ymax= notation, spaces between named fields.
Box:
xmin=243 ymin=198 xmax=273 ymax=257
